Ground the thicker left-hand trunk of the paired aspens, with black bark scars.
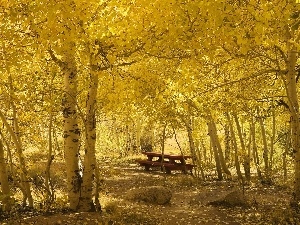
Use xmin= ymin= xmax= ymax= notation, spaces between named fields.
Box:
xmin=62 ymin=55 xmax=82 ymax=211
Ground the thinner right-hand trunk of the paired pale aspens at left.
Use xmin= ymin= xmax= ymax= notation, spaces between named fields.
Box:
xmin=79 ymin=72 xmax=99 ymax=212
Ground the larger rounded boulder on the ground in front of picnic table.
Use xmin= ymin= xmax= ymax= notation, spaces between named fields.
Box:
xmin=125 ymin=186 xmax=172 ymax=205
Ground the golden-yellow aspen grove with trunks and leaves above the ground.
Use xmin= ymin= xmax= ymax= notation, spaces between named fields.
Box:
xmin=0 ymin=0 xmax=300 ymax=223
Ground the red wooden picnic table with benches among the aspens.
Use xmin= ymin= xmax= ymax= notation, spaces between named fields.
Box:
xmin=137 ymin=152 xmax=195 ymax=174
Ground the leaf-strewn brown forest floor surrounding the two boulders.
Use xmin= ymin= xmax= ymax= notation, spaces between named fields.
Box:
xmin=0 ymin=159 xmax=300 ymax=225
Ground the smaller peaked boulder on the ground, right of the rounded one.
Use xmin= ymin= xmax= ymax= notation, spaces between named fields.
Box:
xmin=209 ymin=191 xmax=249 ymax=207
